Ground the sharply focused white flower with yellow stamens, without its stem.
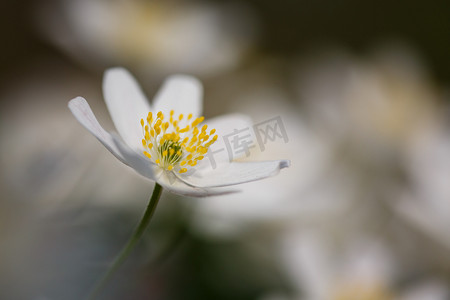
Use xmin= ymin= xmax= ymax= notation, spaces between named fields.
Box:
xmin=69 ymin=68 xmax=290 ymax=196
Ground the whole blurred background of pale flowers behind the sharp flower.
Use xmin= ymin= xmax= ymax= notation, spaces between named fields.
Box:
xmin=0 ymin=0 xmax=450 ymax=300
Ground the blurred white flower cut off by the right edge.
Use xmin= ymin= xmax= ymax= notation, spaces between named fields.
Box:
xmin=389 ymin=120 xmax=450 ymax=249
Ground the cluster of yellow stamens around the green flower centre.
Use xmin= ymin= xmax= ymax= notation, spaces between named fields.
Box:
xmin=141 ymin=110 xmax=218 ymax=173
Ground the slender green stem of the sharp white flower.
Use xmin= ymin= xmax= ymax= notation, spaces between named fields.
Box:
xmin=87 ymin=183 xmax=162 ymax=300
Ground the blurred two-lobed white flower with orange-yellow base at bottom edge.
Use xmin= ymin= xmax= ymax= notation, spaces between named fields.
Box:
xmin=280 ymin=230 xmax=394 ymax=300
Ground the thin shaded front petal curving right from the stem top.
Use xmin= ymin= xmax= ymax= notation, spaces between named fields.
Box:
xmin=153 ymin=171 xmax=238 ymax=197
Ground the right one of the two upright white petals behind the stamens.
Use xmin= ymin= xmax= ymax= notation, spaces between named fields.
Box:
xmin=153 ymin=75 xmax=203 ymax=118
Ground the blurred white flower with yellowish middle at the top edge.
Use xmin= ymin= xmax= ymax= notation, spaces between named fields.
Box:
xmin=41 ymin=0 xmax=256 ymax=76
